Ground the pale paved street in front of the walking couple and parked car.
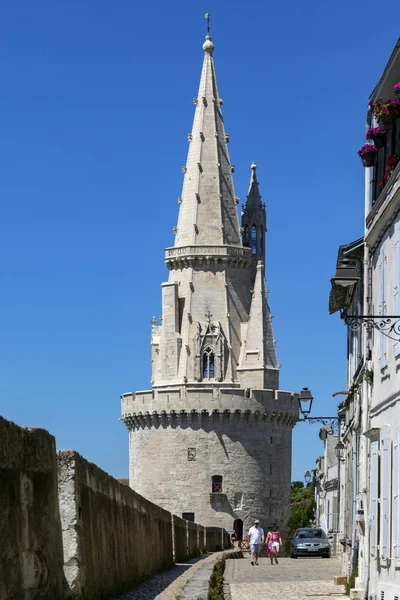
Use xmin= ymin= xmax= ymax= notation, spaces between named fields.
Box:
xmin=225 ymin=554 xmax=348 ymax=600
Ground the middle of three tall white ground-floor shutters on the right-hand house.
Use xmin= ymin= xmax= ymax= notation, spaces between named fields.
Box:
xmin=380 ymin=426 xmax=392 ymax=560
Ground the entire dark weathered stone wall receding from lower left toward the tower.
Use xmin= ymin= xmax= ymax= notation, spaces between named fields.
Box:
xmin=0 ymin=417 xmax=231 ymax=600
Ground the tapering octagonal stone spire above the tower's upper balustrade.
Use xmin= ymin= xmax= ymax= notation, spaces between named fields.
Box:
xmin=175 ymin=34 xmax=242 ymax=247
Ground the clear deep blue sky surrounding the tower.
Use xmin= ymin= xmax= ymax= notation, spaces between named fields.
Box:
xmin=0 ymin=0 xmax=399 ymax=479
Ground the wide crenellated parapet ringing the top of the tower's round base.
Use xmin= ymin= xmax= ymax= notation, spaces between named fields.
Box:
xmin=121 ymin=388 xmax=298 ymax=429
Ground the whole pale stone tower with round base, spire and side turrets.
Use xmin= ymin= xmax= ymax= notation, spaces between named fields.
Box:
xmin=121 ymin=34 xmax=298 ymax=528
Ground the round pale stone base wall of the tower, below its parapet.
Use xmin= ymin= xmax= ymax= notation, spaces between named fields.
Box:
xmin=129 ymin=410 xmax=292 ymax=530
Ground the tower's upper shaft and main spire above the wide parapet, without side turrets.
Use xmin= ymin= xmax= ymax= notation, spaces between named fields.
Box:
xmin=152 ymin=34 xmax=251 ymax=388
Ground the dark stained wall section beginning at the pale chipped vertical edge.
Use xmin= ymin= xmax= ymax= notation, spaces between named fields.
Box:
xmin=58 ymin=450 xmax=173 ymax=598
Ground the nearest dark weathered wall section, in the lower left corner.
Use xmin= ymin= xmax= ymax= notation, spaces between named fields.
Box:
xmin=0 ymin=417 xmax=66 ymax=600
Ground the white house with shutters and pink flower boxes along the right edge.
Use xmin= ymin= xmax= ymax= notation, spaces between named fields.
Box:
xmin=331 ymin=40 xmax=400 ymax=600
